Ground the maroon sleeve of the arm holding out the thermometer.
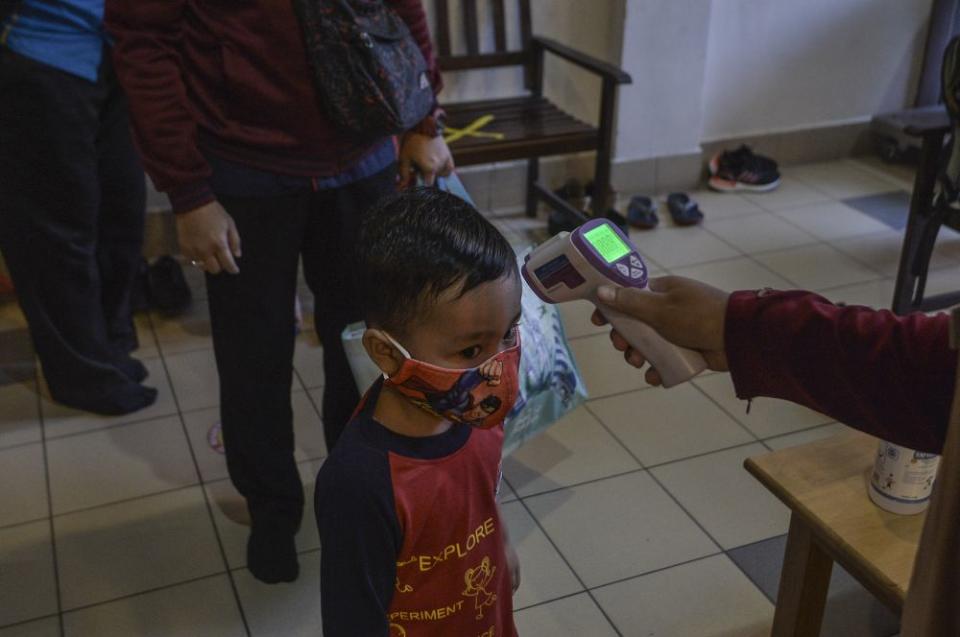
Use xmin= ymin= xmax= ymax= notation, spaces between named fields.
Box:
xmin=725 ymin=291 xmax=957 ymax=453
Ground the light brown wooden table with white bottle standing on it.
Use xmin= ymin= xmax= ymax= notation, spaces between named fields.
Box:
xmin=744 ymin=431 xmax=926 ymax=637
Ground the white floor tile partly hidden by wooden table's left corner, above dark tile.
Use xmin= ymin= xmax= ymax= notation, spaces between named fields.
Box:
xmin=652 ymin=443 xmax=790 ymax=549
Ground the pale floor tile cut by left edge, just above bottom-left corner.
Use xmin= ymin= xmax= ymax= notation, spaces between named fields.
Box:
xmin=0 ymin=520 xmax=57 ymax=624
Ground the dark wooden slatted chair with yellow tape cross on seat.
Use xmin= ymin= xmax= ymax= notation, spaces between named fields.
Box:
xmin=433 ymin=0 xmax=631 ymax=221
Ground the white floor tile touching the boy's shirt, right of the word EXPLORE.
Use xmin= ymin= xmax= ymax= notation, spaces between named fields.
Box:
xmin=500 ymin=502 xmax=583 ymax=608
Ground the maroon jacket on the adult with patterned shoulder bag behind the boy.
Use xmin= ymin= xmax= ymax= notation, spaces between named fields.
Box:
xmin=104 ymin=0 xmax=441 ymax=212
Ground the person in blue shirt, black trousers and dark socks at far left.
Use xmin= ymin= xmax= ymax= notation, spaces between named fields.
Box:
xmin=0 ymin=0 xmax=157 ymax=415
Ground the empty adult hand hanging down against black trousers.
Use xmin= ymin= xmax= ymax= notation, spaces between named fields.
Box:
xmin=175 ymin=201 xmax=240 ymax=274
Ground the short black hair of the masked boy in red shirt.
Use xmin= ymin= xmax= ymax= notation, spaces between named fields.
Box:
xmin=357 ymin=187 xmax=517 ymax=333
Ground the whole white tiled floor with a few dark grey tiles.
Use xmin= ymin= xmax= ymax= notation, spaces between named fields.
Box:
xmin=0 ymin=160 xmax=960 ymax=637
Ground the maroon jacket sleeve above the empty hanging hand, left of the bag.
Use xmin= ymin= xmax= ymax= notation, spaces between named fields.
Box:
xmin=104 ymin=0 xmax=214 ymax=212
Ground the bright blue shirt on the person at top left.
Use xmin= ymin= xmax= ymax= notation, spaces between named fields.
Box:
xmin=0 ymin=0 xmax=108 ymax=82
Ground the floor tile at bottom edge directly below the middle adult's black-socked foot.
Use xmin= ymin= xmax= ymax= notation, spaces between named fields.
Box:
xmin=233 ymin=551 xmax=321 ymax=637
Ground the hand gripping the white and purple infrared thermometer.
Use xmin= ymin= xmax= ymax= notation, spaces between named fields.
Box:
xmin=591 ymin=276 xmax=730 ymax=385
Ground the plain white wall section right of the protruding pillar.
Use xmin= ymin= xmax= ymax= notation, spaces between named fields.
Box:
xmin=702 ymin=0 xmax=931 ymax=141
